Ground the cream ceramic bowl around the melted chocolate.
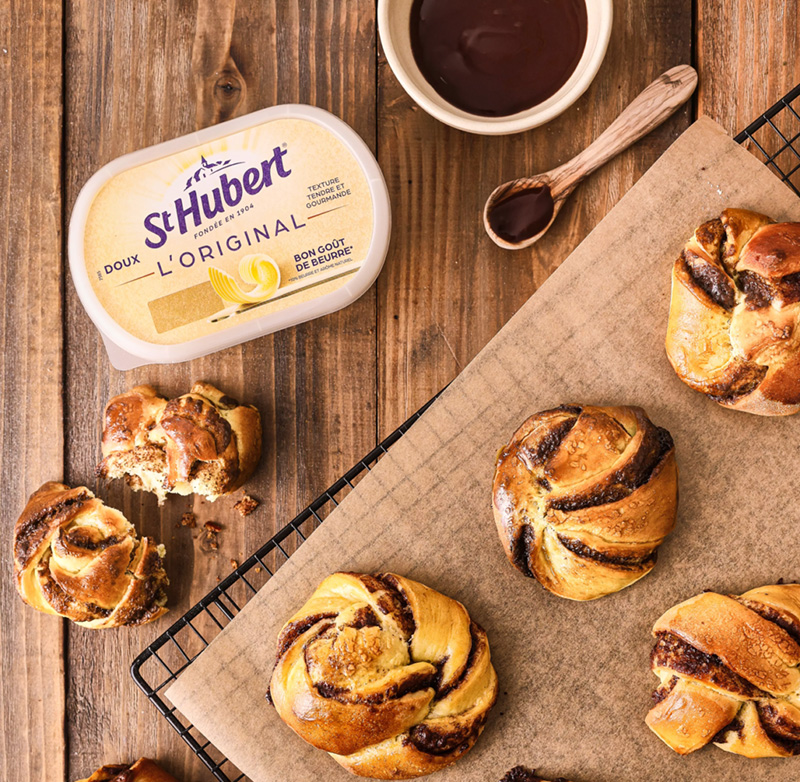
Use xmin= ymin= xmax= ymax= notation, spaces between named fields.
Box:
xmin=378 ymin=0 xmax=614 ymax=136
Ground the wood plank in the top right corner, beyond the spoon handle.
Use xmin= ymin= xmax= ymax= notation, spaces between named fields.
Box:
xmin=697 ymin=0 xmax=800 ymax=135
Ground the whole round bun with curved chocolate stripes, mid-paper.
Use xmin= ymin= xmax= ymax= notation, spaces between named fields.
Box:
xmin=492 ymin=405 xmax=678 ymax=600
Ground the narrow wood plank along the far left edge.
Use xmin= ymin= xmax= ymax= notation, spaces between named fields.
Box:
xmin=0 ymin=0 xmax=65 ymax=782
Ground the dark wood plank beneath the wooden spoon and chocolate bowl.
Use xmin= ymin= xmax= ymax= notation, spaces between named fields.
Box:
xmin=378 ymin=0 xmax=692 ymax=435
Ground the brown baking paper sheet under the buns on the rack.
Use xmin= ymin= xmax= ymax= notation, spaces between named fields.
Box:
xmin=168 ymin=119 xmax=800 ymax=782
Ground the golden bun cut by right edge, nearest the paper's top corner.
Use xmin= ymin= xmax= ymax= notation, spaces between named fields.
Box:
xmin=667 ymin=209 xmax=800 ymax=415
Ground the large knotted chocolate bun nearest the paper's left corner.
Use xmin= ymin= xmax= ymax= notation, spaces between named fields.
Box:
xmin=268 ymin=573 xmax=497 ymax=779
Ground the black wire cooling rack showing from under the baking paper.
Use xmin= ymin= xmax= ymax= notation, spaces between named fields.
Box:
xmin=131 ymin=84 xmax=800 ymax=782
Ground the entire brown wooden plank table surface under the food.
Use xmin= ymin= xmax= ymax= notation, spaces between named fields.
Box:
xmin=0 ymin=0 xmax=800 ymax=782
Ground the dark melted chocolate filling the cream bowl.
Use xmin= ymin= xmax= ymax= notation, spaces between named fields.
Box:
xmin=411 ymin=0 xmax=587 ymax=117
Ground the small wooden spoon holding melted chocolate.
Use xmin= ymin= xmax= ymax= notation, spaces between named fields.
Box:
xmin=483 ymin=65 xmax=697 ymax=250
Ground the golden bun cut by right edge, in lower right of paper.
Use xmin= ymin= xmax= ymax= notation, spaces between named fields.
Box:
xmin=647 ymin=584 xmax=800 ymax=760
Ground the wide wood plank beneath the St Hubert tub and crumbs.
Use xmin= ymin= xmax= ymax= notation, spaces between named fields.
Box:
xmin=66 ymin=0 xmax=376 ymax=782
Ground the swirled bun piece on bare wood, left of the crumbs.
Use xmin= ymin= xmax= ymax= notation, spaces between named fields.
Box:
xmin=14 ymin=482 xmax=169 ymax=629
